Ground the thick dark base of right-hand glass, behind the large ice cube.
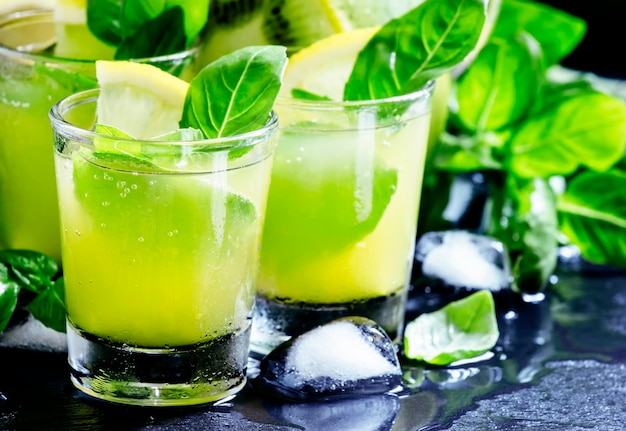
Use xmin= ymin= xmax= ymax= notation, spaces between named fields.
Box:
xmin=250 ymin=289 xmax=406 ymax=355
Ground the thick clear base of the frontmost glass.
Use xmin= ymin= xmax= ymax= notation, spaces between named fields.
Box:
xmin=67 ymin=322 xmax=250 ymax=406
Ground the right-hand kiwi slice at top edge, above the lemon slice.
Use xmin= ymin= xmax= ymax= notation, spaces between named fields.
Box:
xmin=263 ymin=0 xmax=335 ymax=49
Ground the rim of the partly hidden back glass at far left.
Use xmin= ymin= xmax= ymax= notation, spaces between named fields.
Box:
xmin=0 ymin=8 xmax=200 ymax=65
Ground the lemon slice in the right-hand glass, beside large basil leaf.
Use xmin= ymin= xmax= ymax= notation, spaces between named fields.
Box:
xmin=280 ymin=27 xmax=378 ymax=101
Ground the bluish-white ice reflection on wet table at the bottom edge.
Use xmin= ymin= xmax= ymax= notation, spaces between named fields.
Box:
xmin=264 ymin=394 xmax=400 ymax=431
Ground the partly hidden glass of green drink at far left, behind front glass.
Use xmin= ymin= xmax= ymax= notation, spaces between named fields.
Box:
xmin=0 ymin=10 xmax=197 ymax=260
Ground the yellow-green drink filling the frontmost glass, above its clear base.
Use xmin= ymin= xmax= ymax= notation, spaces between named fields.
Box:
xmin=56 ymin=143 xmax=270 ymax=347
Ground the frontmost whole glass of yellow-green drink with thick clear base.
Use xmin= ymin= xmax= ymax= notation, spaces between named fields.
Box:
xmin=50 ymin=90 xmax=277 ymax=406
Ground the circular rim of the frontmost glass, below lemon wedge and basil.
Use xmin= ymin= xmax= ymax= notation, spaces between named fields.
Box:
xmin=48 ymin=88 xmax=278 ymax=150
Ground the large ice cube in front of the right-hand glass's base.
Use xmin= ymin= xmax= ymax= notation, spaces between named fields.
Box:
xmin=259 ymin=317 xmax=402 ymax=400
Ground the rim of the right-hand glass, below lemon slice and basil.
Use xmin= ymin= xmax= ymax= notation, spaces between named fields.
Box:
xmin=275 ymin=79 xmax=435 ymax=111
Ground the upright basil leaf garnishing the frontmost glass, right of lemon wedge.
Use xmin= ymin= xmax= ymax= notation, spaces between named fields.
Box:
xmin=180 ymin=45 xmax=287 ymax=138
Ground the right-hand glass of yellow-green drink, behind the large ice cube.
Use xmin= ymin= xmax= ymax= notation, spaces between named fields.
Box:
xmin=253 ymin=85 xmax=432 ymax=351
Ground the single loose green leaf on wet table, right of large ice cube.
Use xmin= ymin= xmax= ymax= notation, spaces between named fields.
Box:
xmin=404 ymin=290 xmax=500 ymax=365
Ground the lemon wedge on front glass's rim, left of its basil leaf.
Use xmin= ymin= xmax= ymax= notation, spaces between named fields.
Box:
xmin=96 ymin=61 xmax=189 ymax=139
